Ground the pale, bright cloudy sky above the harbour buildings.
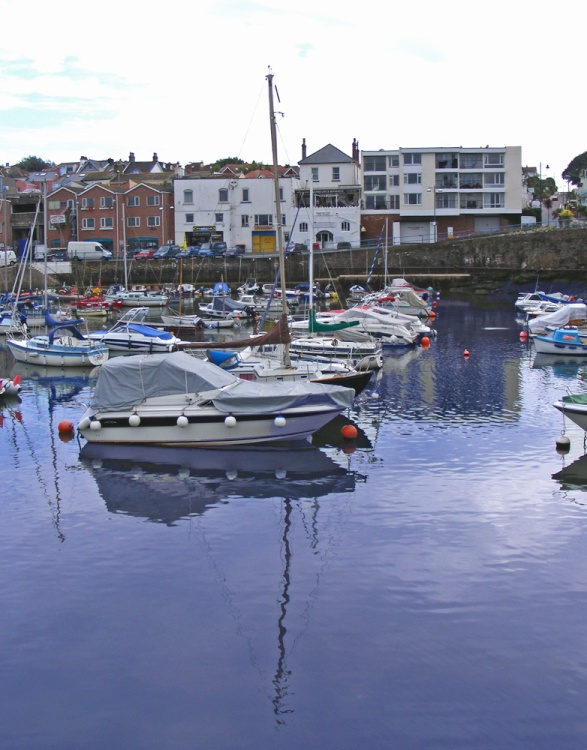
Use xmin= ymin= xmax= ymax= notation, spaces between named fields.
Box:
xmin=0 ymin=0 xmax=587 ymax=189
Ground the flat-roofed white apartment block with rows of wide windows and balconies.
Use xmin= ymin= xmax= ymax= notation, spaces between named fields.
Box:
xmin=361 ymin=146 xmax=523 ymax=244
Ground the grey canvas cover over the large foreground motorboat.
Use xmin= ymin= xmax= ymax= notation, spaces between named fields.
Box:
xmin=90 ymin=352 xmax=355 ymax=414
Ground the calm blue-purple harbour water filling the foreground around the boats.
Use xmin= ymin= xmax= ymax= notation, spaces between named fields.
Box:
xmin=0 ymin=299 xmax=587 ymax=750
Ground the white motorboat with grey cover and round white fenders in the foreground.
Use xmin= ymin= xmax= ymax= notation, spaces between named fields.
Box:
xmin=78 ymin=352 xmax=354 ymax=446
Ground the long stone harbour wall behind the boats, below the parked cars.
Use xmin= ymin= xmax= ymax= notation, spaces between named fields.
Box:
xmin=11 ymin=227 xmax=587 ymax=295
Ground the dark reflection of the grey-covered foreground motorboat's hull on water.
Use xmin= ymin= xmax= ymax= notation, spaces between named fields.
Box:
xmin=80 ymin=443 xmax=355 ymax=525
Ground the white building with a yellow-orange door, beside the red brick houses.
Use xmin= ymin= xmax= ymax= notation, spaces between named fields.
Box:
xmin=173 ymin=171 xmax=299 ymax=252
